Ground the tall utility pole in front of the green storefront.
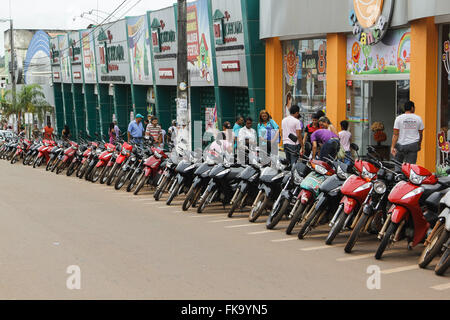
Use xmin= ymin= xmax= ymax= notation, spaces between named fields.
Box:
xmin=177 ymin=0 xmax=191 ymax=148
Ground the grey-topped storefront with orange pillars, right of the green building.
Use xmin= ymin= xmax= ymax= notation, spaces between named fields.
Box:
xmin=260 ymin=0 xmax=450 ymax=170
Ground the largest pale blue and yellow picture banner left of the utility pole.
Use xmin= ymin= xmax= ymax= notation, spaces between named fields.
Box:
xmin=127 ymin=15 xmax=153 ymax=85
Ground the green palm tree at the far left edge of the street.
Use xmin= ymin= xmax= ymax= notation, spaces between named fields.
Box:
xmin=0 ymin=84 xmax=53 ymax=128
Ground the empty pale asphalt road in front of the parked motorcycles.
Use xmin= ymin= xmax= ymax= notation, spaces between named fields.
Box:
xmin=0 ymin=160 xmax=450 ymax=300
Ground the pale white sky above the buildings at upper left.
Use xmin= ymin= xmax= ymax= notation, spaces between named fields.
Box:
xmin=0 ymin=0 xmax=176 ymax=56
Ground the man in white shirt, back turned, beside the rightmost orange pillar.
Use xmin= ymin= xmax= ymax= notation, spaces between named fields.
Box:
xmin=391 ymin=101 xmax=425 ymax=164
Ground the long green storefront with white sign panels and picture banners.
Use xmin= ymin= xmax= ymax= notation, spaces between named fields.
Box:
xmin=50 ymin=0 xmax=265 ymax=144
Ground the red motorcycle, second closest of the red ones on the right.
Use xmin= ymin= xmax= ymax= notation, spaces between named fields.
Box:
xmin=325 ymin=160 xmax=380 ymax=245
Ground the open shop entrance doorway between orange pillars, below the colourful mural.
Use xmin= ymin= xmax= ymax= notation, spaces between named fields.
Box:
xmin=347 ymin=80 xmax=409 ymax=160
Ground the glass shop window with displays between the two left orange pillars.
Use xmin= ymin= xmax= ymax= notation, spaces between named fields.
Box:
xmin=283 ymin=39 xmax=327 ymax=123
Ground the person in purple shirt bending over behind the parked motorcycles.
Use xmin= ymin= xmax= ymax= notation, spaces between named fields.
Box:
xmin=311 ymin=117 xmax=340 ymax=161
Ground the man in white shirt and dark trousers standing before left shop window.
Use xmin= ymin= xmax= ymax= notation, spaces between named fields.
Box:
xmin=281 ymin=105 xmax=304 ymax=166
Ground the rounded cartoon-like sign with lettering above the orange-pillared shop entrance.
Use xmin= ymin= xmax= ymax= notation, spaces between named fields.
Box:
xmin=349 ymin=0 xmax=394 ymax=45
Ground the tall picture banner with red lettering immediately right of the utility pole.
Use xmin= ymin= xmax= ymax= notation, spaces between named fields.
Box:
xmin=187 ymin=0 xmax=214 ymax=86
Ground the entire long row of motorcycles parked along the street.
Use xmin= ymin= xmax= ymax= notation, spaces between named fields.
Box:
xmin=0 ymin=135 xmax=450 ymax=275
